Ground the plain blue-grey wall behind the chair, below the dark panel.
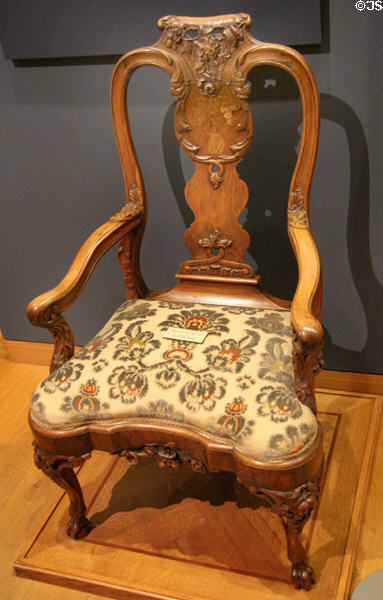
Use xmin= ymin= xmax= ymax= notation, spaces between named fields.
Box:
xmin=0 ymin=0 xmax=383 ymax=373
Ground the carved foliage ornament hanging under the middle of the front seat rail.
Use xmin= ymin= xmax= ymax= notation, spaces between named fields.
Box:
xmin=115 ymin=442 xmax=207 ymax=473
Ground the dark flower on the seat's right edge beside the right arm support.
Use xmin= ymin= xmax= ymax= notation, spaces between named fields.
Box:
xmin=258 ymin=338 xmax=294 ymax=389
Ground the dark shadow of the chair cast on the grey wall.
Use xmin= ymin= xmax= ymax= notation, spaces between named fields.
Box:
xmin=162 ymin=66 xmax=383 ymax=372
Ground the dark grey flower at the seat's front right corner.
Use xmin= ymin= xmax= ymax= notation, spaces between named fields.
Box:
xmin=256 ymin=385 xmax=302 ymax=423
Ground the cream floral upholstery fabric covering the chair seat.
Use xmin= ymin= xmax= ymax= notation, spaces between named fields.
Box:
xmin=31 ymin=300 xmax=318 ymax=462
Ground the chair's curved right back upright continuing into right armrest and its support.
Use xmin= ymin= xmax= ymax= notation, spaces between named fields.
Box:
xmin=239 ymin=42 xmax=323 ymax=412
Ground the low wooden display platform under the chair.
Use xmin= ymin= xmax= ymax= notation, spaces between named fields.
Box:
xmin=15 ymin=392 xmax=380 ymax=600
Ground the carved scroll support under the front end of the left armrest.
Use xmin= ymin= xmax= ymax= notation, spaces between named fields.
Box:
xmin=39 ymin=305 xmax=74 ymax=373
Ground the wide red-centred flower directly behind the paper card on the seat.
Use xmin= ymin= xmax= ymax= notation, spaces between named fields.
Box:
xmin=159 ymin=309 xmax=229 ymax=335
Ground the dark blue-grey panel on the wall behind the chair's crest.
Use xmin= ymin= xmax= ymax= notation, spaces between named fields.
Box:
xmin=0 ymin=0 xmax=321 ymax=60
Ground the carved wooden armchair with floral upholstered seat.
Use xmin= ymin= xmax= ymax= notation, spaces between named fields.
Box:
xmin=28 ymin=14 xmax=323 ymax=589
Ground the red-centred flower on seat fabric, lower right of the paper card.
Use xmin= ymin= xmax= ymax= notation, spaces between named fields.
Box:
xmin=204 ymin=331 xmax=260 ymax=373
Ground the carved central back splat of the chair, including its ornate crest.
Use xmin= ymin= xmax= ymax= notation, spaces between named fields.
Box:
xmin=158 ymin=15 xmax=258 ymax=283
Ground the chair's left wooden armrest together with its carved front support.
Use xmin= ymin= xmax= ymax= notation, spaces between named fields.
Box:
xmin=27 ymin=209 xmax=142 ymax=372
